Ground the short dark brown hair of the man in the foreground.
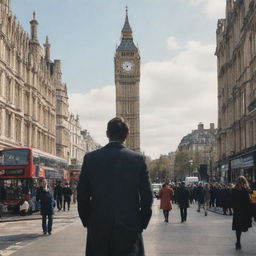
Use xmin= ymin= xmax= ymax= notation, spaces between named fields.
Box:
xmin=107 ymin=117 xmax=129 ymax=142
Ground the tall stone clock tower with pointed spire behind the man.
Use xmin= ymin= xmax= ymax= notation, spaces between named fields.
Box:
xmin=115 ymin=7 xmax=140 ymax=151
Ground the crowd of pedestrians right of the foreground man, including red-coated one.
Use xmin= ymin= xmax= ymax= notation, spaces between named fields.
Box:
xmin=159 ymin=176 xmax=256 ymax=250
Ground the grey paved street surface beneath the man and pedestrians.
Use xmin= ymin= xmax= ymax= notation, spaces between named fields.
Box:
xmin=0 ymin=200 xmax=256 ymax=256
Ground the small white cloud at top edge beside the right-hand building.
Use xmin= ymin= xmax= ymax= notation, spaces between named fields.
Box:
xmin=190 ymin=0 xmax=226 ymax=19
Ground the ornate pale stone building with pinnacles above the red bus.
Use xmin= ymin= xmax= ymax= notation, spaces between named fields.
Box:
xmin=0 ymin=0 xmax=68 ymax=158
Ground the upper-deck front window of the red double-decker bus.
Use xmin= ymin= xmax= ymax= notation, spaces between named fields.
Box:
xmin=0 ymin=149 xmax=29 ymax=166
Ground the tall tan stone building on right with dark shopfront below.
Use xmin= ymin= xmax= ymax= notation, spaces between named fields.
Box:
xmin=216 ymin=0 xmax=256 ymax=181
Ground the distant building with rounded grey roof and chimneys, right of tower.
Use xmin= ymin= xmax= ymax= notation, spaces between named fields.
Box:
xmin=178 ymin=123 xmax=219 ymax=181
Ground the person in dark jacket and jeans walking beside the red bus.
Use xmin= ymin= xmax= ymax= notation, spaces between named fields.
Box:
xmin=36 ymin=178 xmax=54 ymax=235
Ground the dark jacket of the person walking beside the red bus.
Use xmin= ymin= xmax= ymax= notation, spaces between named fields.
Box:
xmin=36 ymin=187 xmax=54 ymax=215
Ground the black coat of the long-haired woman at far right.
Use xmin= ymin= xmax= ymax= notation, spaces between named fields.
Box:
xmin=232 ymin=189 xmax=252 ymax=232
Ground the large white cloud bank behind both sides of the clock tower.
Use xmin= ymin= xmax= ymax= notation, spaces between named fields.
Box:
xmin=70 ymin=41 xmax=217 ymax=157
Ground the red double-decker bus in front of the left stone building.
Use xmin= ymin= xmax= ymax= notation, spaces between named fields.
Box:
xmin=0 ymin=148 xmax=69 ymax=211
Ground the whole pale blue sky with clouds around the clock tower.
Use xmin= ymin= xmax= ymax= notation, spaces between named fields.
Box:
xmin=11 ymin=0 xmax=226 ymax=159
